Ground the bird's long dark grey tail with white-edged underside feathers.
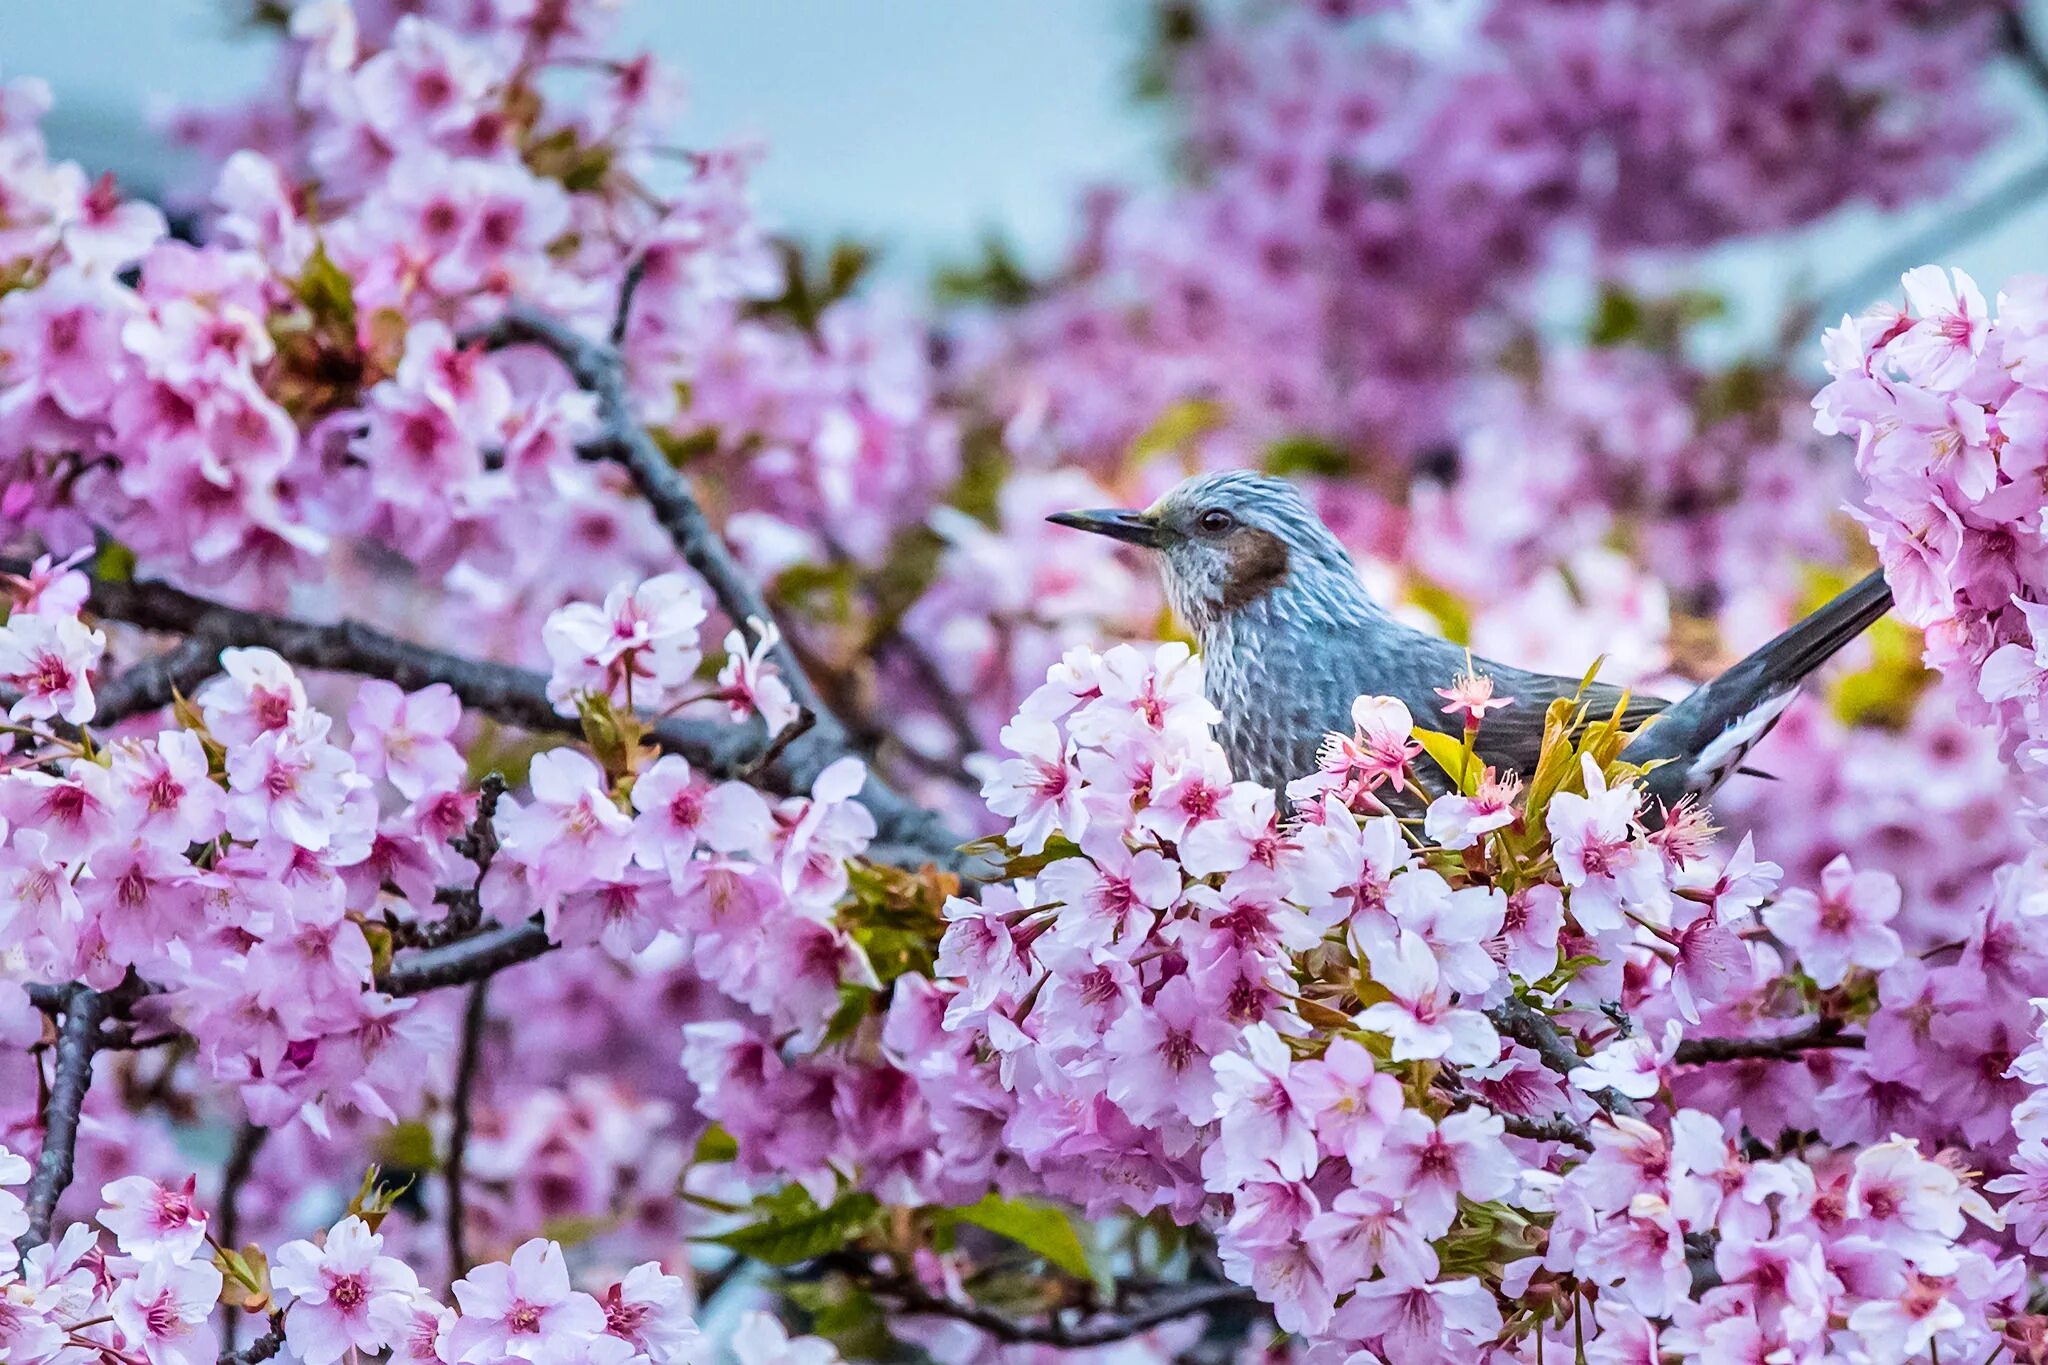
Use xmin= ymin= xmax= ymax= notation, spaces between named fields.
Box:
xmin=1622 ymin=573 xmax=1892 ymax=800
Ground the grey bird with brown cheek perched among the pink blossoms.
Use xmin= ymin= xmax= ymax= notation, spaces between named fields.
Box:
xmin=1047 ymin=471 xmax=1892 ymax=810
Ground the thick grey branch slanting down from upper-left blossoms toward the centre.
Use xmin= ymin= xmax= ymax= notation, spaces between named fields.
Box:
xmin=463 ymin=300 xmax=965 ymax=872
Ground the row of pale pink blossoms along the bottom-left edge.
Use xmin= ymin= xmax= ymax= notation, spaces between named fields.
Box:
xmin=0 ymin=1148 xmax=856 ymax=1365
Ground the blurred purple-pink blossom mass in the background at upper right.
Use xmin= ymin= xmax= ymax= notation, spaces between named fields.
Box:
xmin=978 ymin=0 xmax=1997 ymax=477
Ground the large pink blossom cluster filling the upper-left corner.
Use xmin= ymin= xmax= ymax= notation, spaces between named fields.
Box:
xmin=0 ymin=2 xmax=954 ymax=653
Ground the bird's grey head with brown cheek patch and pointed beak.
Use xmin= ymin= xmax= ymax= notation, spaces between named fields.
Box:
xmin=1047 ymin=471 xmax=1358 ymax=630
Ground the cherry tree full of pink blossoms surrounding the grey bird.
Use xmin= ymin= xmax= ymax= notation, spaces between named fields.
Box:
xmin=0 ymin=0 xmax=2048 ymax=1365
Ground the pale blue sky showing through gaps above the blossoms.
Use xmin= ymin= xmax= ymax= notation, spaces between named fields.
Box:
xmin=16 ymin=0 xmax=2048 ymax=344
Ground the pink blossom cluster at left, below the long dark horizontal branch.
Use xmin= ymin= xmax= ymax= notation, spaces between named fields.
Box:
xmin=0 ymin=567 xmax=874 ymax=1126
